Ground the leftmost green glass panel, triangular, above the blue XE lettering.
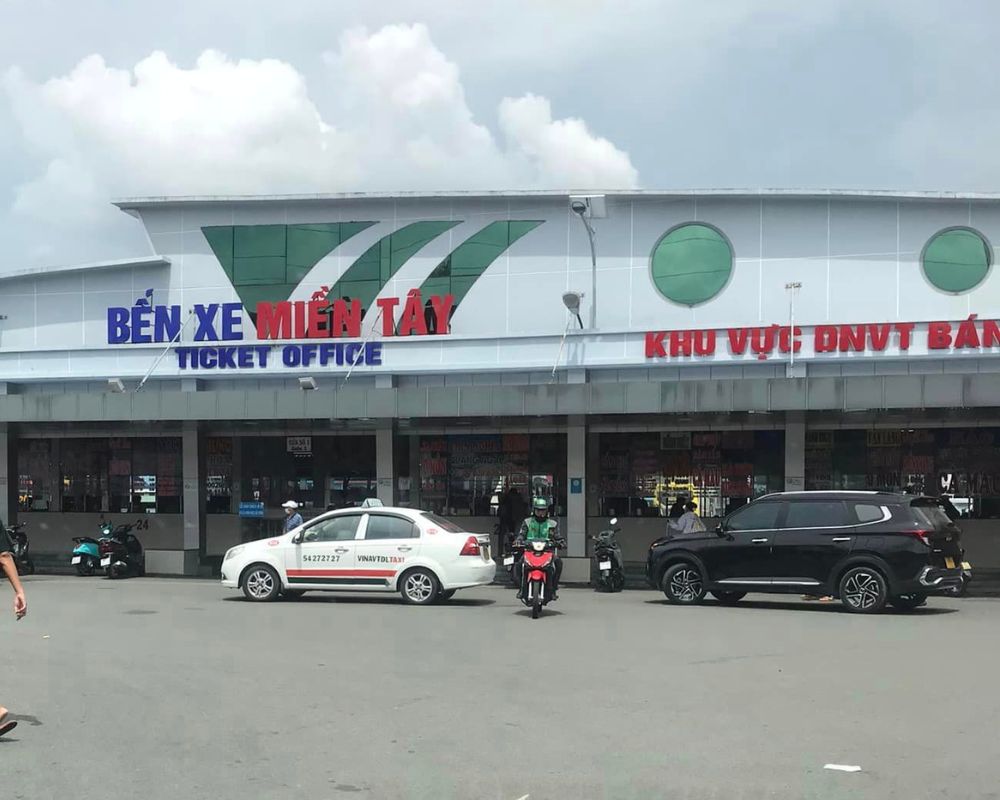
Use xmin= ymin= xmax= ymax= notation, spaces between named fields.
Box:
xmin=201 ymin=222 xmax=375 ymax=314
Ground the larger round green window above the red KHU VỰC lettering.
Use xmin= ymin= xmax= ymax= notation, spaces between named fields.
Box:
xmin=649 ymin=222 xmax=733 ymax=306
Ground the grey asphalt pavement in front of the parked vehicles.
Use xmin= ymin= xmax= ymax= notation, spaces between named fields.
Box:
xmin=0 ymin=577 xmax=1000 ymax=800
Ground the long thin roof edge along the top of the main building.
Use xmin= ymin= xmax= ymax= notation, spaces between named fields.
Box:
xmin=113 ymin=189 xmax=1000 ymax=211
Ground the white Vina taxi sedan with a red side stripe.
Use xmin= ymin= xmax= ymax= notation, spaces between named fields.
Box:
xmin=222 ymin=506 xmax=496 ymax=605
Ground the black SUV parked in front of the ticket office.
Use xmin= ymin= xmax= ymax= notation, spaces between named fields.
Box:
xmin=646 ymin=492 xmax=962 ymax=613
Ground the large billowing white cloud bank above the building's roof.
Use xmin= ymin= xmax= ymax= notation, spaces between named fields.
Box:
xmin=0 ymin=24 xmax=637 ymax=268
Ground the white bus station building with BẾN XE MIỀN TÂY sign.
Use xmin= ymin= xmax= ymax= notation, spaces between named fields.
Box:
xmin=0 ymin=192 xmax=1000 ymax=578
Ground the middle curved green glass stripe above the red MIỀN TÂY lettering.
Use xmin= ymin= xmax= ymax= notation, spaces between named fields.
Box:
xmin=326 ymin=220 xmax=461 ymax=309
